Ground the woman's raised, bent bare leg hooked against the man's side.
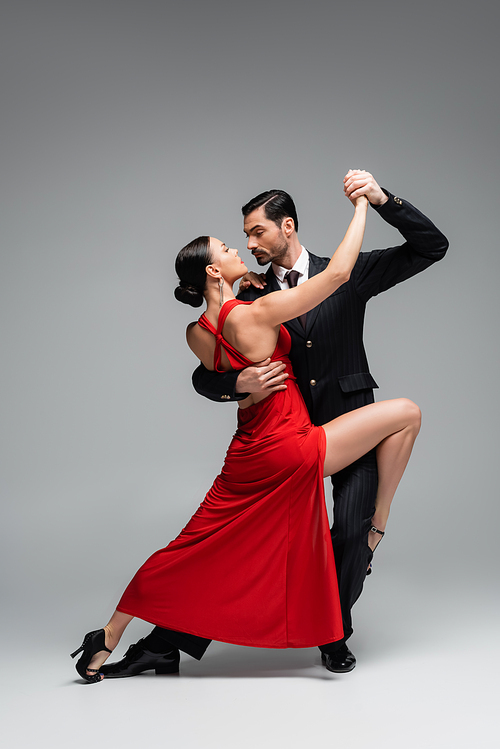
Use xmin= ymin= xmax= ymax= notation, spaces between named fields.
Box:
xmin=323 ymin=398 xmax=421 ymax=549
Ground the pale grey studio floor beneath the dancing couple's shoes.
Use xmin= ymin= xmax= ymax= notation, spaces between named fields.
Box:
xmin=2 ymin=568 xmax=500 ymax=749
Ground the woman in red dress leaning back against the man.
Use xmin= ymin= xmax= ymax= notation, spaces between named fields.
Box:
xmin=73 ymin=187 xmax=420 ymax=681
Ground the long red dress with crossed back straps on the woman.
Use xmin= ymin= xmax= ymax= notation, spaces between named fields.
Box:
xmin=117 ymin=299 xmax=343 ymax=648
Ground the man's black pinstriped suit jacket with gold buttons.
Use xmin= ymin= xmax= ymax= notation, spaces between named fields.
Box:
xmin=193 ymin=191 xmax=448 ymax=425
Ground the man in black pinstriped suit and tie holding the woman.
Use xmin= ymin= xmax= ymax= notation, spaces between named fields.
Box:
xmin=101 ymin=170 xmax=448 ymax=677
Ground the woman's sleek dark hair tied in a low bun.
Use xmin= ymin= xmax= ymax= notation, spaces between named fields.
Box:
xmin=174 ymin=237 xmax=212 ymax=307
